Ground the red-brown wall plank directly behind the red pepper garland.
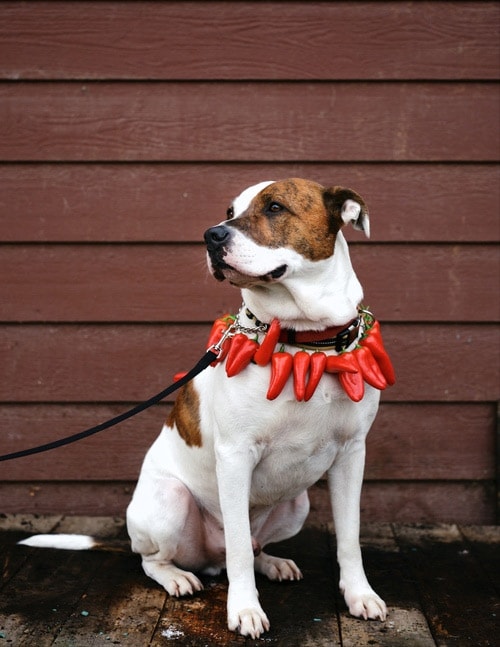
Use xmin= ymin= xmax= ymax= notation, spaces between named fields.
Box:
xmin=0 ymin=322 xmax=500 ymax=403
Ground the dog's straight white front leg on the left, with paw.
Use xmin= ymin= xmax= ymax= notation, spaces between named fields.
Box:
xmin=217 ymin=447 xmax=269 ymax=639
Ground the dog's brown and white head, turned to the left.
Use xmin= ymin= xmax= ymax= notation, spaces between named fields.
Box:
xmin=205 ymin=178 xmax=370 ymax=288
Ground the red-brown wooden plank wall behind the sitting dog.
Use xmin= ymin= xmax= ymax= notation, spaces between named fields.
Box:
xmin=0 ymin=1 xmax=500 ymax=523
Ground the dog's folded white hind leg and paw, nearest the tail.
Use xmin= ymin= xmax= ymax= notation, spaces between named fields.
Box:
xmin=127 ymin=478 xmax=211 ymax=597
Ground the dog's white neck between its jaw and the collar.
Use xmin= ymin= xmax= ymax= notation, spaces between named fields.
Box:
xmin=242 ymin=232 xmax=363 ymax=331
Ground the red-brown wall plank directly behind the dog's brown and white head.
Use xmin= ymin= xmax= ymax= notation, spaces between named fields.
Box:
xmin=0 ymin=163 xmax=500 ymax=244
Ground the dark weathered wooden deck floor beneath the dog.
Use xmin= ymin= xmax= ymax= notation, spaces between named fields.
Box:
xmin=0 ymin=515 xmax=500 ymax=647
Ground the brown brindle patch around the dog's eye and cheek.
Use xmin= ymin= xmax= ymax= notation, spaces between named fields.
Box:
xmin=228 ymin=178 xmax=350 ymax=261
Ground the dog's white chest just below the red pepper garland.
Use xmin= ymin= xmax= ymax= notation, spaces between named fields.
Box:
xmin=205 ymin=368 xmax=370 ymax=498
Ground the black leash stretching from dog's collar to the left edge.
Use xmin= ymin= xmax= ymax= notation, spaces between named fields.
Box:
xmin=0 ymin=347 xmax=218 ymax=461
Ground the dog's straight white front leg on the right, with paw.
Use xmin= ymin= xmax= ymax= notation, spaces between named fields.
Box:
xmin=328 ymin=439 xmax=387 ymax=620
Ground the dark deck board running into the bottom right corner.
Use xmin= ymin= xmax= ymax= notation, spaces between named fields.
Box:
xmin=396 ymin=526 xmax=498 ymax=647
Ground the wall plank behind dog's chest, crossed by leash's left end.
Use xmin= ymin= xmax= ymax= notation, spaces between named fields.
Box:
xmin=0 ymin=403 xmax=495 ymax=484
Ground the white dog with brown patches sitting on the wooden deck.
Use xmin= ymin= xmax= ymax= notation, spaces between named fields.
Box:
xmin=20 ymin=178 xmax=387 ymax=639
